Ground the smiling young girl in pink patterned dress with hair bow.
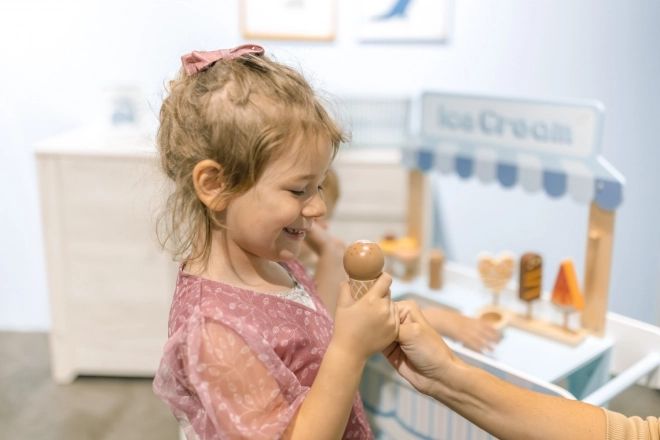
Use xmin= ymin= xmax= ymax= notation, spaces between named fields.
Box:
xmin=154 ymin=45 xmax=399 ymax=440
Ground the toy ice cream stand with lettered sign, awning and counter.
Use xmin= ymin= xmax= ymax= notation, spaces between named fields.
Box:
xmin=360 ymin=93 xmax=660 ymax=440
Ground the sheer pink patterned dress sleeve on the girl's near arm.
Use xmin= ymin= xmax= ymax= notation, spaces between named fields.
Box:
xmin=183 ymin=321 xmax=309 ymax=440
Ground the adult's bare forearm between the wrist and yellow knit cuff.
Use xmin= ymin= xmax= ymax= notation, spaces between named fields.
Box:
xmin=431 ymin=364 xmax=606 ymax=440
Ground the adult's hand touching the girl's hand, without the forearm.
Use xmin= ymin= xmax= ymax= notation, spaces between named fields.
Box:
xmin=383 ymin=301 xmax=462 ymax=395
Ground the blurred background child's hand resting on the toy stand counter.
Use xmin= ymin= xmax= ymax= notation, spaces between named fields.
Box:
xmin=422 ymin=308 xmax=500 ymax=352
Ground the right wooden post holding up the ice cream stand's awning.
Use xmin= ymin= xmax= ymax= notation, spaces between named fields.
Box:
xmin=582 ymin=202 xmax=615 ymax=336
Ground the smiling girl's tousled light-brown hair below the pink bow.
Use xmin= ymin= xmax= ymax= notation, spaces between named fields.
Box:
xmin=157 ymin=54 xmax=347 ymax=261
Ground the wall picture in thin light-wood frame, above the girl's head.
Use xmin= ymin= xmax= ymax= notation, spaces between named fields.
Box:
xmin=239 ymin=0 xmax=336 ymax=41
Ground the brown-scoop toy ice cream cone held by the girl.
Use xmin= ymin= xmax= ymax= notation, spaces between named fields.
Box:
xmin=344 ymin=240 xmax=385 ymax=301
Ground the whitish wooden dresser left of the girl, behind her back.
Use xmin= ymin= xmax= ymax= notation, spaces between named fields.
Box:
xmin=36 ymin=128 xmax=177 ymax=383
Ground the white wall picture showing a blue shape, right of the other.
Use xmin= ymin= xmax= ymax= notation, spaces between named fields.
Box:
xmin=357 ymin=0 xmax=451 ymax=42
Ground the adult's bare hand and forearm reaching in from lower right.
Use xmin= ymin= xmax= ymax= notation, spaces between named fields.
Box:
xmin=383 ymin=301 xmax=612 ymax=440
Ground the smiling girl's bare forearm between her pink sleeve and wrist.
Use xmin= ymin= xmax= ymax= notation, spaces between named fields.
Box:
xmin=285 ymin=343 xmax=366 ymax=440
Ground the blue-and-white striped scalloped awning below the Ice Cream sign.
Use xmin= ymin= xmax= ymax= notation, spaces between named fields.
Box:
xmin=403 ymin=144 xmax=625 ymax=211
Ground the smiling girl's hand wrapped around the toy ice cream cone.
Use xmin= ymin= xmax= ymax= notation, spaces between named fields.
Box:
xmin=330 ymin=273 xmax=400 ymax=362
